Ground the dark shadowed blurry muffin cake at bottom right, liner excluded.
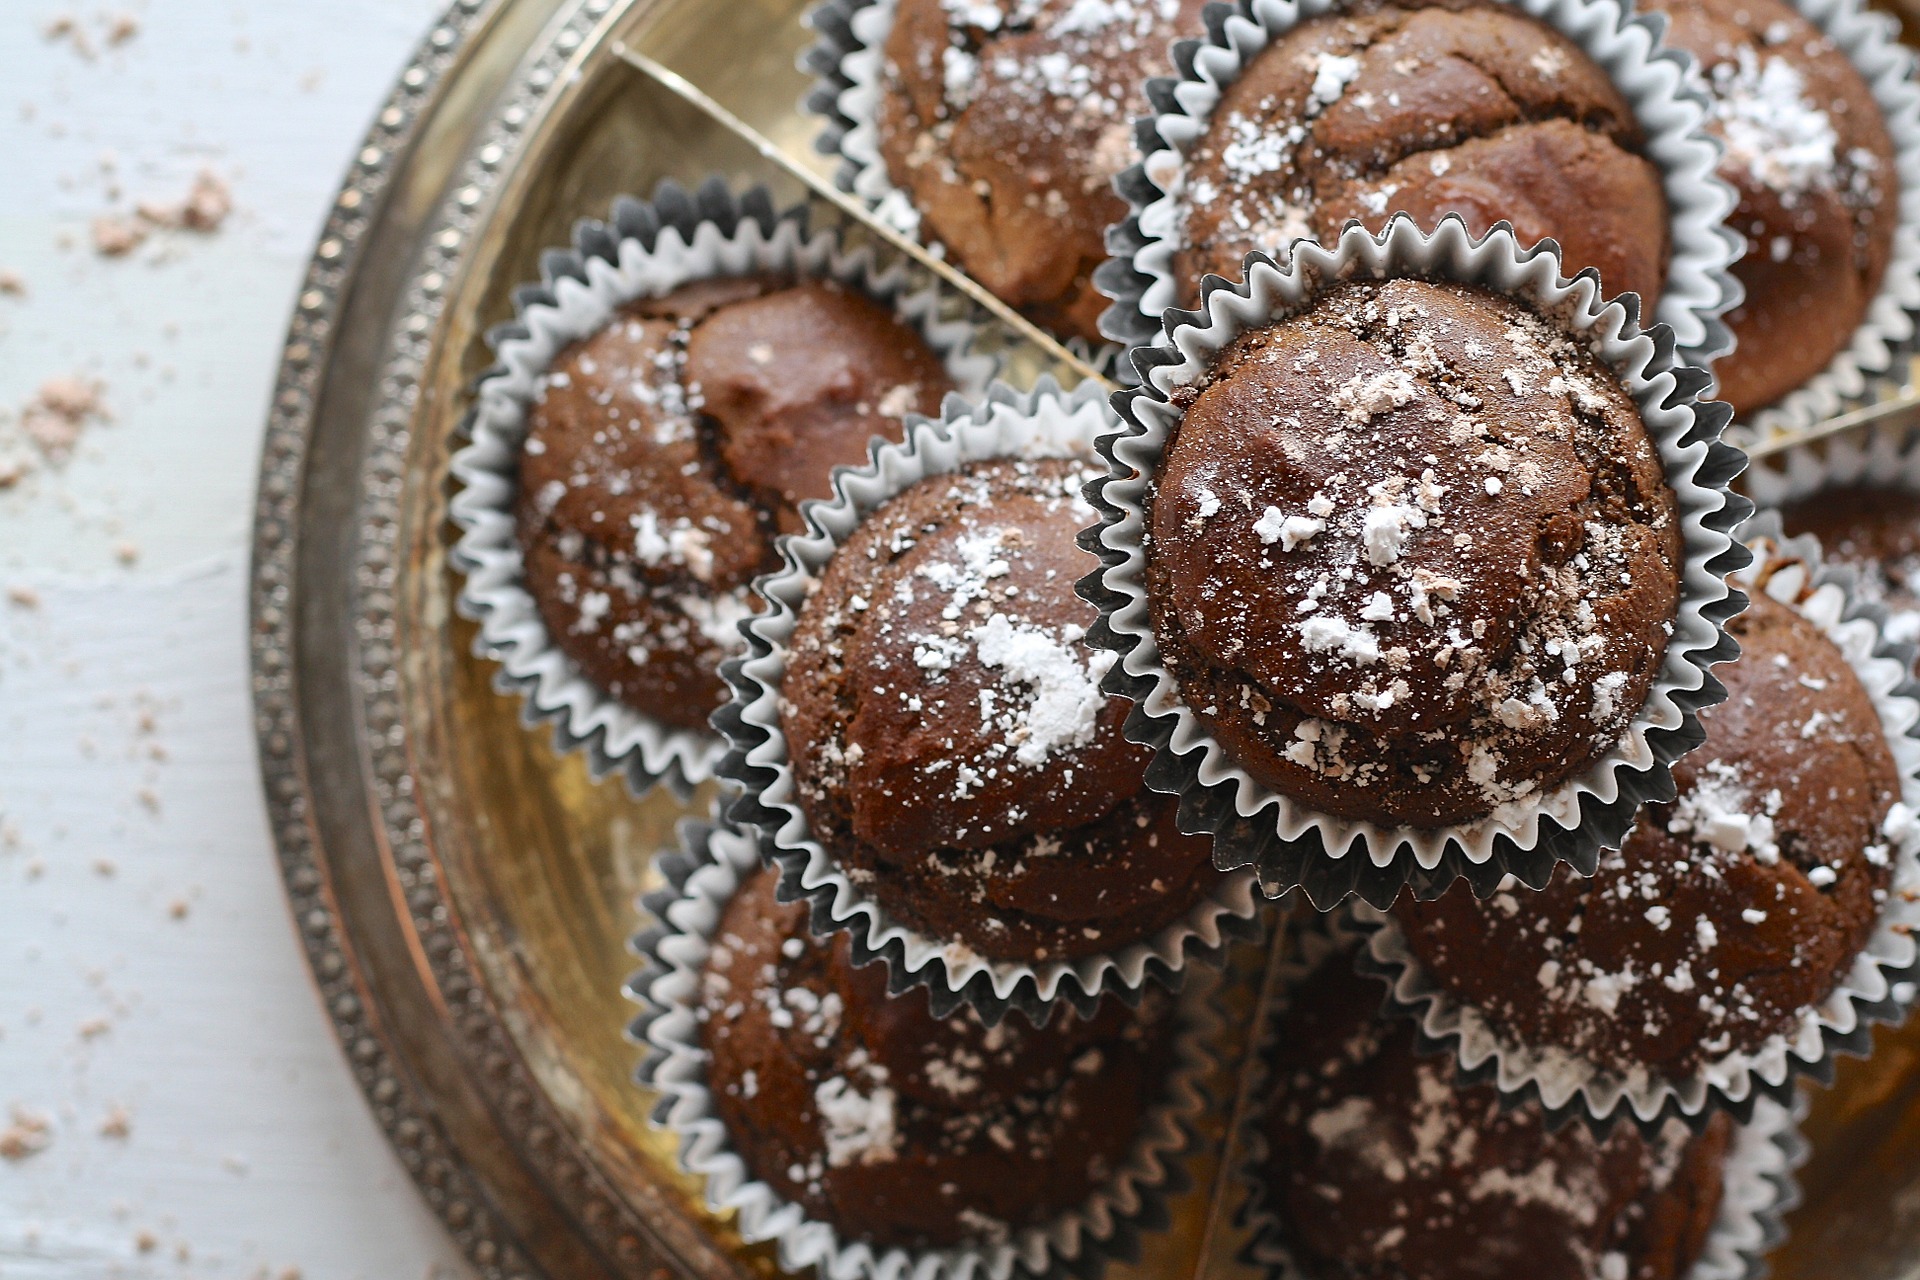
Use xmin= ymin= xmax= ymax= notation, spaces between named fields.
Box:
xmin=1261 ymin=958 xmax=1732 ymax=1280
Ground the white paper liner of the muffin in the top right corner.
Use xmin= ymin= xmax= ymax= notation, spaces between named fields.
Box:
xmin=1734 ymin=0 xmax=1920 ymax=441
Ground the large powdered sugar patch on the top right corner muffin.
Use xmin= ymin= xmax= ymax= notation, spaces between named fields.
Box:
xmin=1711 ymin=48 xmax=1839 ymax=194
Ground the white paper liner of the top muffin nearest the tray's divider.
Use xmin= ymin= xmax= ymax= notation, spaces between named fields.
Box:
xmin=799 ymin=0 xmax=1123 ymax=368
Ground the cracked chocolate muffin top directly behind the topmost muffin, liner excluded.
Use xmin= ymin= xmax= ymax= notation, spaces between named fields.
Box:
xmin=1173 ymin=0 xmax=1668 ymax=315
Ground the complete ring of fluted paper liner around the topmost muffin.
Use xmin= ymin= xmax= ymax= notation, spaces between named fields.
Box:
xmin=1081 ymin=215 xmax=1751 ymax=910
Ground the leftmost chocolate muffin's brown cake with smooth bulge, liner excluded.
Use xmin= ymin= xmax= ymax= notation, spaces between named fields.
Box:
xmin=515 ymin=276 xmax=952 ymax=729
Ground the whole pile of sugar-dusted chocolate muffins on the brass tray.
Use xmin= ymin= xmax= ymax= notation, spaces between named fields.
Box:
xmin=441 ymin=0 xmax=1920 ymax=1280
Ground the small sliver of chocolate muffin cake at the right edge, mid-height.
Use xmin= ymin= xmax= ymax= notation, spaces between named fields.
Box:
xmin=1780 ymin=486 xmax=1920 ymax=645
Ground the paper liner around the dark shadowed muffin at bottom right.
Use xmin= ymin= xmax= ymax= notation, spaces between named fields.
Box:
xmin=1238 ymin=913 xmax=1809 ymax=1280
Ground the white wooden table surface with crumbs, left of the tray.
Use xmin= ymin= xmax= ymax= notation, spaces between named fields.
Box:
xmin=0 ymin=0 xmax=465 ymax=1280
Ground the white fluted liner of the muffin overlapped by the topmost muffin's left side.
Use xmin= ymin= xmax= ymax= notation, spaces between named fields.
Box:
xmin=714 ymin=378 xmax=1258 ymax=1023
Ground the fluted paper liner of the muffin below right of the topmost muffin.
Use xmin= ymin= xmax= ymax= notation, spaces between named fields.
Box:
xmin=1354 ymin=512 xmax=1920 ymax=1126
